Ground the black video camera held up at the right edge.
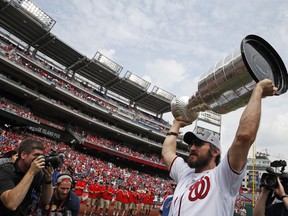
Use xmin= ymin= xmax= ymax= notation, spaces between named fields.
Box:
xmin=261 ymin=160 xmax=288 ymax=190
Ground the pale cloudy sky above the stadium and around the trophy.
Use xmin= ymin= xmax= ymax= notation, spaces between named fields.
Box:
xmin=33 ymin=0 xmax=288 ymax=161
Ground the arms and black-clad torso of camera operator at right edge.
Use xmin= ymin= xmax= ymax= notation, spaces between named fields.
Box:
xmin=253 ymin=177 xmax=288 ymax=216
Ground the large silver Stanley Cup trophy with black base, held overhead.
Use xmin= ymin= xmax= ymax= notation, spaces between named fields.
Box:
xmin=171 ymin=35 xmax=288 ymax=122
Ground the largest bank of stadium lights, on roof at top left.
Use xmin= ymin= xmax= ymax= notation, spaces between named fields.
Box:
xmin=14 ymin=0 xmax=56 ymax=30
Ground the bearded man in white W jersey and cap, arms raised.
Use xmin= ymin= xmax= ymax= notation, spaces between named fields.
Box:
xmin=162 ymin=79 xmax=277 ymax=216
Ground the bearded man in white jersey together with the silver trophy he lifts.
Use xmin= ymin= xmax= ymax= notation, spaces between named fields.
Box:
xmin=162 ymin=36 xmax=287 ymax=216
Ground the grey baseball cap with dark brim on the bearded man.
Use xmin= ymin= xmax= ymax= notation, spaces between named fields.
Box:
xmin=183 ymin=130 xmax=221 ymax=151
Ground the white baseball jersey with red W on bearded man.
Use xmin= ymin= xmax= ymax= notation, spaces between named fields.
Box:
xmin=169 ymin=155 xmax=246 ymax=216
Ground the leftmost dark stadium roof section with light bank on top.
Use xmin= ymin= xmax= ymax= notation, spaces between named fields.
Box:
xmin=0 ymin=0 xmax=85 ymax=67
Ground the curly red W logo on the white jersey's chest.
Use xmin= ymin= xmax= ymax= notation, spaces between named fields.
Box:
xmin=188 ymin=176 xmax=210 ymax=202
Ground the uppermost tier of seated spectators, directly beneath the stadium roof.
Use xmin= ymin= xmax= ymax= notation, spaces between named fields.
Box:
xmin=0 ymin=38 xmax=169 ymax=133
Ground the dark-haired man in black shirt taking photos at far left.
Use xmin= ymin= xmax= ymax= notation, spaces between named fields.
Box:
xmin=0 ymin=138 xmax=53 ymax=216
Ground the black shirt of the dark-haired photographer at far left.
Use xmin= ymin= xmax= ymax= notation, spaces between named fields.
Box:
xmin=0 ymin=163 xmax=43 ymax=216
